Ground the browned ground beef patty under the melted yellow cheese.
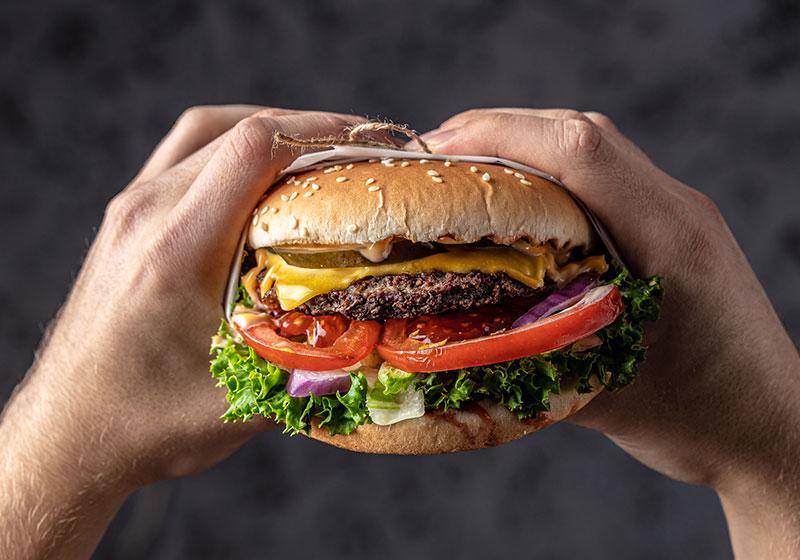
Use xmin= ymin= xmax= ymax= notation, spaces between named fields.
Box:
xmin=259 ymin=271 xmax=550 ymax=321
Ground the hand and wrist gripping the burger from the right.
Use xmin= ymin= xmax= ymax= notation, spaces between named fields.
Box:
xmin=423 ymin=109 xmax=800 ymax=553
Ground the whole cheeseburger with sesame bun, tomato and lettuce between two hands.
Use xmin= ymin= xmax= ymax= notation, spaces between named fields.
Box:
xmin=211 ymin=154 xmax=661 ymax=454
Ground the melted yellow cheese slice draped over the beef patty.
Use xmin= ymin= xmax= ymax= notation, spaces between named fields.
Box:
xmin=242 ymin=247 xmax=608 ymax=311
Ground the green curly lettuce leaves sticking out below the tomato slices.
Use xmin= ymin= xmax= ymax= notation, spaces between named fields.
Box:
xmin=211 ymin=268 xmax=663 ymax=434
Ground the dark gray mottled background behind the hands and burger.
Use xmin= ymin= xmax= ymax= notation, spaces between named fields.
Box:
xmin=0 ymin=0 xmax=800 ymax=559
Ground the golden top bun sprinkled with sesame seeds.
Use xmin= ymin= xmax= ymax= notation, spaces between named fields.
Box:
xmin=248 ymin=155 xmax=594 ymax=248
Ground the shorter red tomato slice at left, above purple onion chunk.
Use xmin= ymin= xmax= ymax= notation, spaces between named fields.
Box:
xmin=234 ymin=313 xmax=381 ymax=371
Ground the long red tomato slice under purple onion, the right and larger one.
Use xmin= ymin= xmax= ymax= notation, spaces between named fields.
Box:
xmin=377 ymin=285 xmax=624 ymax=372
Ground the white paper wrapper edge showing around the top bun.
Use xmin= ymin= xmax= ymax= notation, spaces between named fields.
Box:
xmin=223 ymin=146 xmax=622 ymax=320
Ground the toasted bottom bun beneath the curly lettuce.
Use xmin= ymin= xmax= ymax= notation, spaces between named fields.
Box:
xmin=310 ymin=376 xmax=601 ymax=455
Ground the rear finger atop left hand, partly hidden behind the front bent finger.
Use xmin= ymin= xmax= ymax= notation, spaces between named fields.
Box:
xmin=135 ymin=105 xmax=272 ymax=181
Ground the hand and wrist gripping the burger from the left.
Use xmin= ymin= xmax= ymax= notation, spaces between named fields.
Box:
xmin=0 ymin=106 xmax=358 ymax=558
